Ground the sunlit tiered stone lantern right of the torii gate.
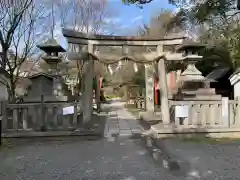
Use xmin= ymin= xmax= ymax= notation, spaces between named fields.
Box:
xmin=174 ymin=42 xmax=221 ymax=100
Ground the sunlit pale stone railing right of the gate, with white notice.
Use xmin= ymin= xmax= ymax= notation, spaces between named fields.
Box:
xmin=169 ymin=100 xmax=240 ymax=128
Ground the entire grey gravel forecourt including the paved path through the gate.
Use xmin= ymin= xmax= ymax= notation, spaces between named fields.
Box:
xmin=0 ymin=102 xmax=240 ymax=180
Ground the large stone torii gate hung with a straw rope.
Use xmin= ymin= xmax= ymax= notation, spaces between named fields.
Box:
xmin=62 ymin=29 xmax=185 ymax=124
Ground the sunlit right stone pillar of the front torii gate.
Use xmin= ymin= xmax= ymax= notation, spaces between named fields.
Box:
xmin=157 ymin=45 xmax=170 ymax=124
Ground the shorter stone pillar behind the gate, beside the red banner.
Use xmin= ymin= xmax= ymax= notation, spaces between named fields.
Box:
xmin=145 ymin=64 xmax=154 ymax=112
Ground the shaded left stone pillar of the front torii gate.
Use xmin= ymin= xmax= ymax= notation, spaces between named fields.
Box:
xmin=82 ymin=44 xmax=94 ymax=123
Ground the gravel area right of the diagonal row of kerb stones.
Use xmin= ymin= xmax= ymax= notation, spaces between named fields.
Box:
xmin=159 ymin=139 xmax=240 ymax=180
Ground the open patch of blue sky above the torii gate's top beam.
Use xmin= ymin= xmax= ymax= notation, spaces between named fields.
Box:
xmin=56 ymin=0 xmax=175 ymax=48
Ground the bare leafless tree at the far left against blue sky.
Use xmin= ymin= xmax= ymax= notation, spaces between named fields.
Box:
xmin=0 ymin=0 xmax=48 ymax=101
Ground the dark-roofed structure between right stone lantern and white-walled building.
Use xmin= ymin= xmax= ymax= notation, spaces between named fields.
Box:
xmin=206 ymin=67 xmax=233 ymax=99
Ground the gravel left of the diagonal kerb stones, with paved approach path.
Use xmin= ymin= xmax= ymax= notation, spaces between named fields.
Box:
xmin=0 ymin=103 xmax=179 ymax=180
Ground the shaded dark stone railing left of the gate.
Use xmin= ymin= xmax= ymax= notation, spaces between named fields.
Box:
xmin=1 ymin=102 xmax=80 ymax=132
